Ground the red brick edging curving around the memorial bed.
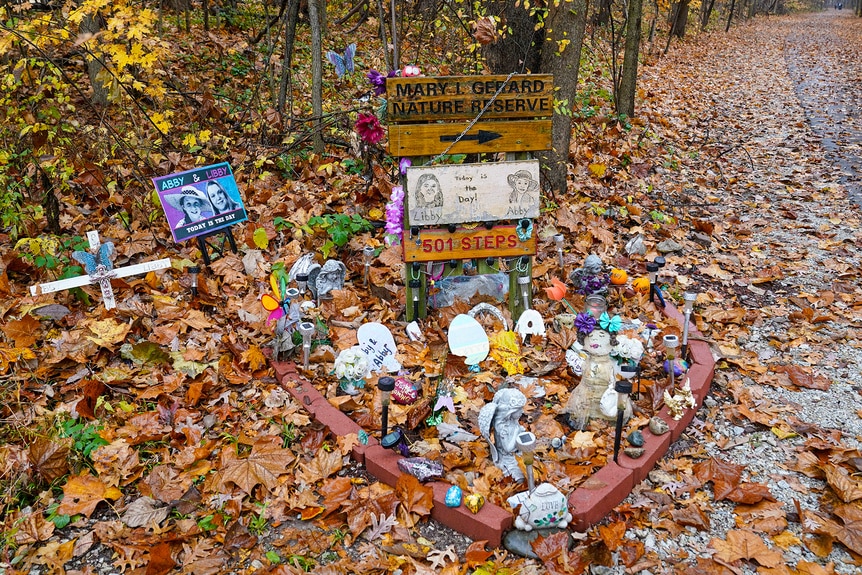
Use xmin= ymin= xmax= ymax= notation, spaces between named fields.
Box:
xmin=271 ymin=304 xmax=715 ymax=547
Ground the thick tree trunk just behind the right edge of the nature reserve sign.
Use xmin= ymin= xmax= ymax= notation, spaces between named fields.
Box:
xmin=536 ymin=0 xmax=588 ymax=193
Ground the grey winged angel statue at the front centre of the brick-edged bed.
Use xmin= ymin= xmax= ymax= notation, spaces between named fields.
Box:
xmin=479 ymin=388 xmax=527 ymax=482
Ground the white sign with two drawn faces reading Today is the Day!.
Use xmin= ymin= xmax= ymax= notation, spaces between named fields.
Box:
xmin=407 ymin=160 xmax=539 ymax=226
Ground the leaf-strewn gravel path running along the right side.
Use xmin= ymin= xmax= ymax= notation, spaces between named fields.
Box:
xmin=627 ymin=11 xmax=862 ymax=574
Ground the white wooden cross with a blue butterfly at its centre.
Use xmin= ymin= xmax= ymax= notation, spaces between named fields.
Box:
xmin=30 ymin=231 xmax=171 ymax=309
